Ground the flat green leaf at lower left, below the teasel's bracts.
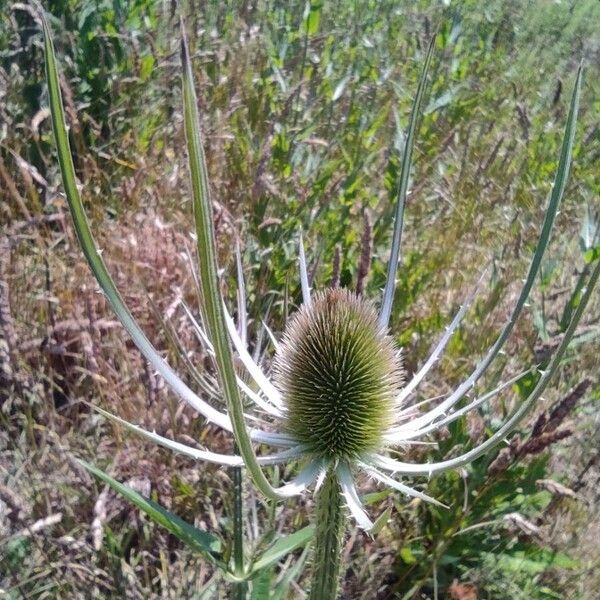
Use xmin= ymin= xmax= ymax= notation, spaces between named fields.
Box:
xmin=78 ymin=460 xmax=227 ymax=571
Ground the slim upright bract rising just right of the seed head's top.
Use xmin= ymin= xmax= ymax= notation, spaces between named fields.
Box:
xmin=379 ymin=36 xmax=436 ymax=327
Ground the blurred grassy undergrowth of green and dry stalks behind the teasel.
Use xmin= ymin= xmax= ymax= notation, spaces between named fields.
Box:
xmin=0 ymin=0 xmax=600 ymax=600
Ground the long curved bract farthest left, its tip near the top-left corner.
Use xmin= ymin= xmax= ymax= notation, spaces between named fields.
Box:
xmin=42 ymin=17 xmax=232 ymax=431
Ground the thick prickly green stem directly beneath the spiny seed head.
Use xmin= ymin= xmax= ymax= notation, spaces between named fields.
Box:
xmin=309 ymin=469 xmax=346 ymax=600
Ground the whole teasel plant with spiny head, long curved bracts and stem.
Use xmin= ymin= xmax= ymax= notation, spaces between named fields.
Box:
xmin=44 ymin=12 xmax=600 ymax=599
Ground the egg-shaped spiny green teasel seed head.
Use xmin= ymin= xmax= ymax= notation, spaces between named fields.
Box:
xmin=274 ymin=288 xmax=402 ymax=459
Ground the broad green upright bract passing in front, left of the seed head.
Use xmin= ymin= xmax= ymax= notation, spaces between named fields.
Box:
xmin=181 ymin=27 xmax=280 ymax=499
